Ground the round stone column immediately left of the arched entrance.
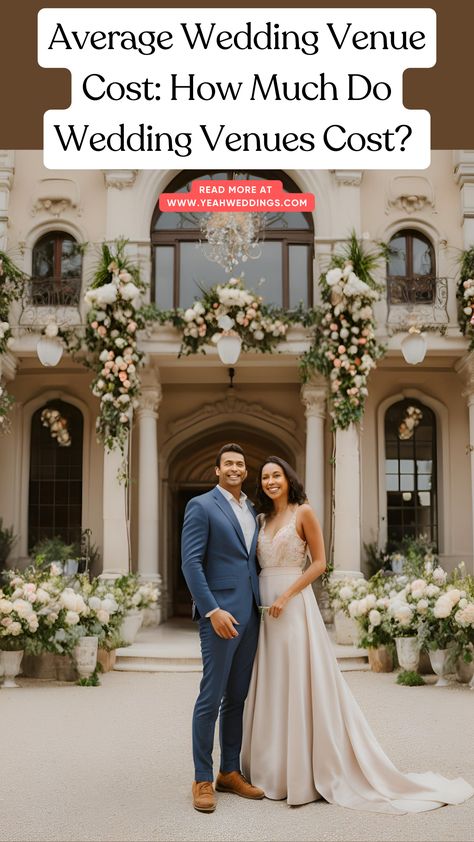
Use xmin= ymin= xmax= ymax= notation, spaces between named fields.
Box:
xmin=137 ymin=383 xmax=162 ymax=582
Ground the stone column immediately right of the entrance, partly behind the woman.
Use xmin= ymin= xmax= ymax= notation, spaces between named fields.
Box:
xmin=301 ymin=377 xmax=327 ymax=528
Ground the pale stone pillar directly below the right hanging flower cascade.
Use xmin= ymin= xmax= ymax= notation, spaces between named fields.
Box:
xmin=333 ymin=424 xmax=362 ymax=578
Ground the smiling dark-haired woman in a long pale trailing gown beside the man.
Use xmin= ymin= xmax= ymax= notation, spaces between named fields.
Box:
xmin=242 ymin=456 xmax=474 ymax=813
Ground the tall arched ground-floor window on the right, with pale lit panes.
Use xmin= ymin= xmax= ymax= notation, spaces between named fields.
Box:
xmin=385 ymin=398 xmax=438 ymax=549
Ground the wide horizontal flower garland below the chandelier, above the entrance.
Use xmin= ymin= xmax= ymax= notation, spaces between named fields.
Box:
xmin=154 ymin=277 xmax=308 ymax=356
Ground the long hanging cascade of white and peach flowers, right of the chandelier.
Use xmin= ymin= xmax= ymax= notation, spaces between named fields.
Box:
xmin=300 ymin=234 xmax=386 ymax=429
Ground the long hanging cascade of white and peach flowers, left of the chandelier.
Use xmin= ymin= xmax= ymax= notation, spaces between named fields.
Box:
xmin=65 ymin=240 xmax=145 ymax=453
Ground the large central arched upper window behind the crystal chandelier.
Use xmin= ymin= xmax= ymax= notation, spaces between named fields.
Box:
xmin=151 ymin=171 xmax=314 ymax=309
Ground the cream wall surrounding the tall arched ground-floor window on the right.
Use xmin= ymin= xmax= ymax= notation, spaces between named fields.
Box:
xmin=361 ymin=363 xmax=473 ymax=568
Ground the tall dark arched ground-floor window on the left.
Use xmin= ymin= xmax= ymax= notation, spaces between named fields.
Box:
xmin=28 ymin=400 xmax=84 ymax=550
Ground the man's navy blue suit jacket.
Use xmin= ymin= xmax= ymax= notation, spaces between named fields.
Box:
xmin=181 ymin=488 xmax=260 ymax=622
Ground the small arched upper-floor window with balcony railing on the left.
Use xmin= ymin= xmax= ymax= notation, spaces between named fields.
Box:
xmin=31 ymin=231 xmax=82 ymax=307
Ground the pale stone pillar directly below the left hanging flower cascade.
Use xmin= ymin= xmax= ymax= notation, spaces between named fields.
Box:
xmin=102 ymin=448 xmax=129 ymax=579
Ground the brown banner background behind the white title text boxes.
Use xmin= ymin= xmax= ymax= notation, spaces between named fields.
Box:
xmin=0 ymin=0 xmax=474 ymax=149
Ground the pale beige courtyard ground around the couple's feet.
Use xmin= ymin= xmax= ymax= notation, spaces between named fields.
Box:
xmin=0 ymin=672 xmax=474 ymax=842
